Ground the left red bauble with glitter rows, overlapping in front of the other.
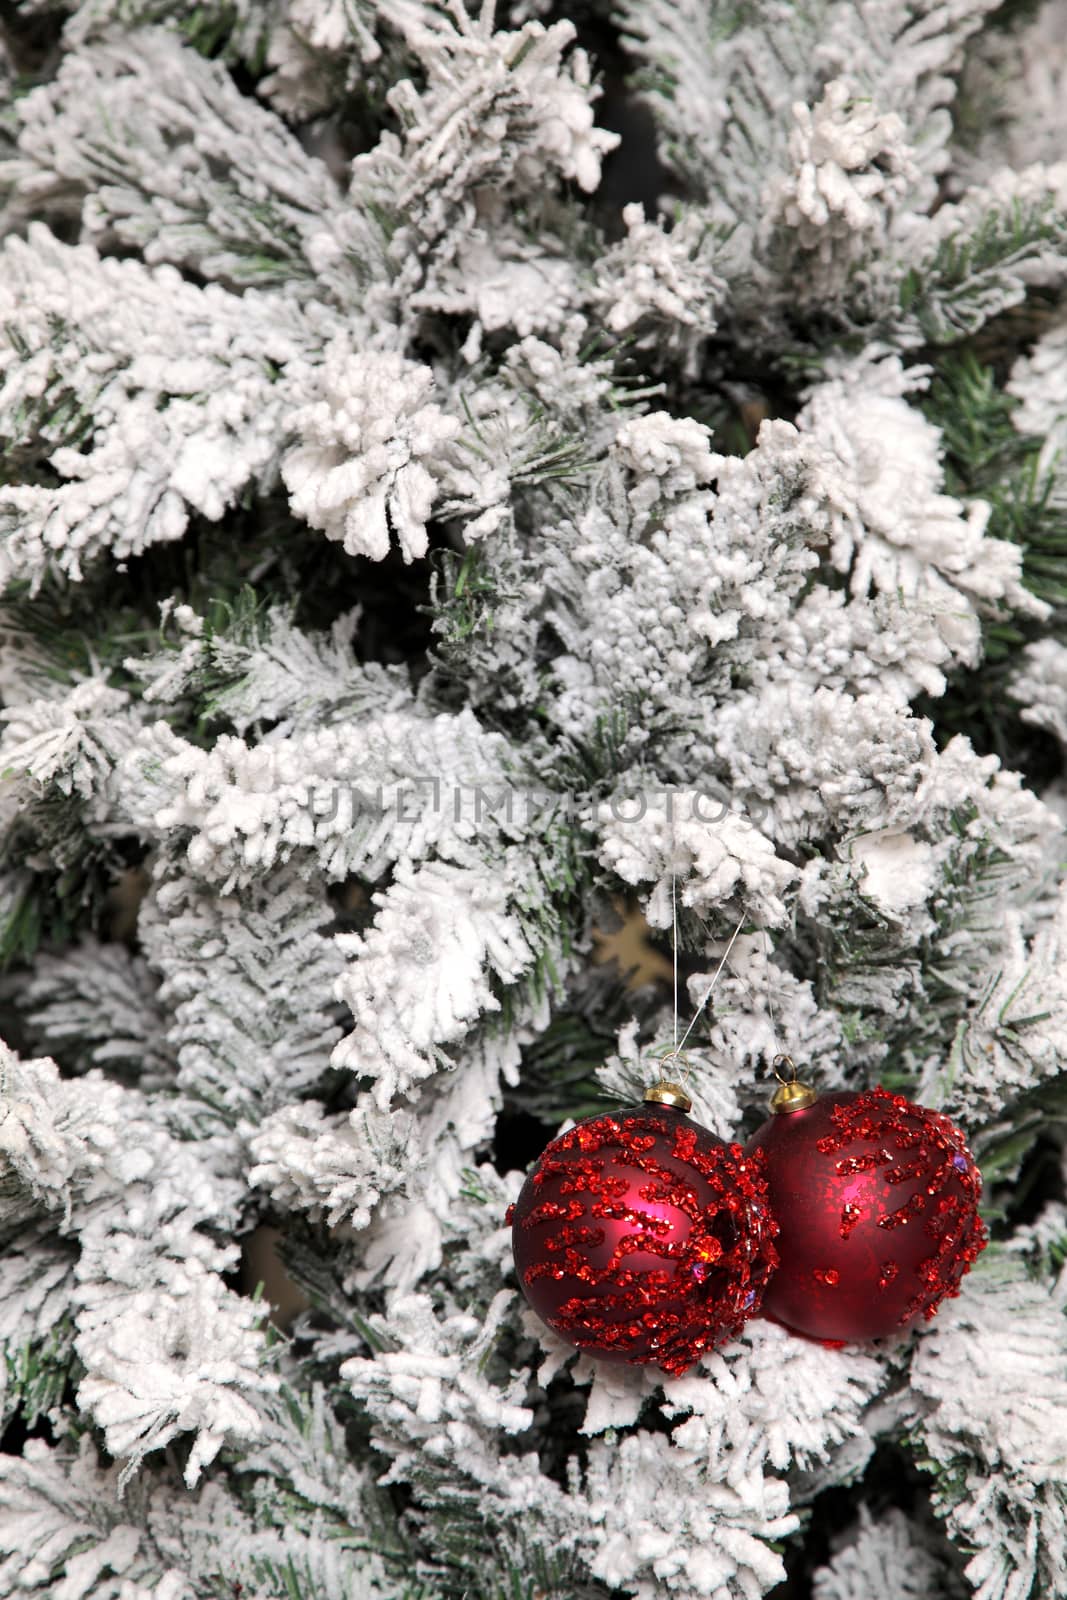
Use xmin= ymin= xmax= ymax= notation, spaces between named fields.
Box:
xmin=509 ymin=1104 xmax=777 ymax=1373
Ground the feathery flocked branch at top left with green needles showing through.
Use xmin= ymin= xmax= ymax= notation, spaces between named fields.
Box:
xmin=4 ymin=29 xmax=350 ymax=285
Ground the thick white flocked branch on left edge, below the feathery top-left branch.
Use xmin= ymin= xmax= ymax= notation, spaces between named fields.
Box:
xmin=0 ymin=224 xmax=316 ymax=584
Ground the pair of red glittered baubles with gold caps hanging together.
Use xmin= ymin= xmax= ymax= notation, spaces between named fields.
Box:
xmin=509 ymin=1078 xmax=987 ymax=1374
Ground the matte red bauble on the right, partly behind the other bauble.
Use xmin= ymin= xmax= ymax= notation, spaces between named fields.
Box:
xmin=749 ymin=1088 xmax=987 ymax=1339
